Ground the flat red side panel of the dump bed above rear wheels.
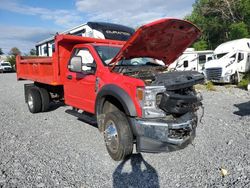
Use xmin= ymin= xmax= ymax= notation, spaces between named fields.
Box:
xmin=16 ymin=56 xmax=62 ymax=85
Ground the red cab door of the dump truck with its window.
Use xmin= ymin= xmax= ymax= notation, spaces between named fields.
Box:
xmin=64 ymin=47 xmax=96 ymax=113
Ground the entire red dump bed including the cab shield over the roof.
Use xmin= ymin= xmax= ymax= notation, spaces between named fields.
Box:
xmin=16 ymin=35 xmax=125 ymax=86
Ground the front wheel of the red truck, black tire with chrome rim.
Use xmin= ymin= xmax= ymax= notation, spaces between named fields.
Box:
xmin=103 ymin=111 xmax=133 ymax=161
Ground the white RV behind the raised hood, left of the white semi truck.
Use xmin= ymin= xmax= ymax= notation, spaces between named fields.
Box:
xmin=168 ymin=48 xmax=213 ymax=72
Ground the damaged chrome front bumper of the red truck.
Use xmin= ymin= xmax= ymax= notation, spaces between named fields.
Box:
xmin=133 ymin=112 xmax=197 ymax=153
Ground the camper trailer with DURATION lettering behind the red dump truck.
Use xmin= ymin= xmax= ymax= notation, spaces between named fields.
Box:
xmin=36 ymin=22 xmax=135 ymax=56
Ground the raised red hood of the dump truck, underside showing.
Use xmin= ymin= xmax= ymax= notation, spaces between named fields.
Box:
xmin=110 ymin=18 xmax=201 ymax=65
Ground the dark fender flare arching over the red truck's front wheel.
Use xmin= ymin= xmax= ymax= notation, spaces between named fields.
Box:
xmin=95 ymin=84 xmax=137 ymax=117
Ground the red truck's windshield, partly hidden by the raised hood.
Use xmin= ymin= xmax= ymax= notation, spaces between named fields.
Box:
xmin=95 ymin=46 xmax=165 ymax=66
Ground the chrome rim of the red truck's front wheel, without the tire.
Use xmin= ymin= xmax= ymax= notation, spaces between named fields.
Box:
xmin=104 ymin=120 xmax=119 ymax=152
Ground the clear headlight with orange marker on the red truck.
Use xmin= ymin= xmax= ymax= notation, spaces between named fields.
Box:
xmin=137 ymin=86 xmax=166 ymax=118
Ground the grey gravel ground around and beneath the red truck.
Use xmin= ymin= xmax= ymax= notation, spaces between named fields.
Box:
xmin=0 ymin=74 xmax=250 ymax=187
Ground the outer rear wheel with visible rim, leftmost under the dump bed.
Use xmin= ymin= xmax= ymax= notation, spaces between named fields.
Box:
xmin=27 ymin=87 xmax=42 ymax=113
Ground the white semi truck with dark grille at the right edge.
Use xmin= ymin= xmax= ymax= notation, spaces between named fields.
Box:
xmin=204 ymin=38 xmax=250 ymax=84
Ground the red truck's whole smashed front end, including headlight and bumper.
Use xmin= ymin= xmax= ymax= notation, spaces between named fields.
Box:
xmin=131 ymin=71 xmax=204 ymax=152
